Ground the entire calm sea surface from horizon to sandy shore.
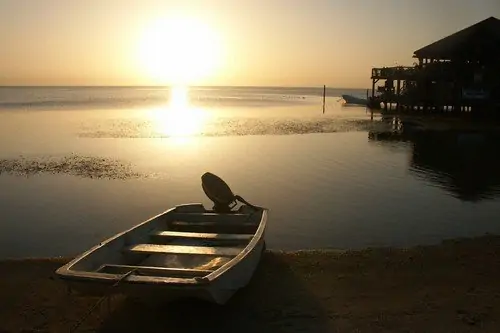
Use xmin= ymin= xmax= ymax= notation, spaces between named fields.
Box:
xmin=0 ymin=88 xmax=500 ymax=258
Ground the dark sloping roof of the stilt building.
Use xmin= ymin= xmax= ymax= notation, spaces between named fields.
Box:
xmin=414 ymin=17 xmax=500 ymax=60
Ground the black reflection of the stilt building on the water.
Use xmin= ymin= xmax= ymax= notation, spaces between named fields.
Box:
xmin=369 ymin=117 xmax=500 ymax=201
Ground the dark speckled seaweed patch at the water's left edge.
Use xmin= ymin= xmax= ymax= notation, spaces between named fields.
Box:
xmin=0 ymin=154 xmax=145 ymax=180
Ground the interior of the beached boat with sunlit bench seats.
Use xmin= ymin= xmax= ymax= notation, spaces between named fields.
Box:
xmin=68 ymin=204 xmax=262 ymax=278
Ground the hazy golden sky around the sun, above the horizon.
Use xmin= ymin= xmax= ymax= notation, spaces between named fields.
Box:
xmin=0 ymin=0 xmax=500 ymax=87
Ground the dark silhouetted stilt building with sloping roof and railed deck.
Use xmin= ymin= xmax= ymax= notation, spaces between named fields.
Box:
xmin=369 ymin=17 xmax=500 ymax=115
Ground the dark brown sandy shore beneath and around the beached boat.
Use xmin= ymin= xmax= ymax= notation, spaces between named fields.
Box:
xmin=0 ymin=236 xmax=500 ymax=333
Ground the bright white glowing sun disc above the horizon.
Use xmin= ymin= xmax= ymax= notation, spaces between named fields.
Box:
xmin=138 ymin=17 xmax=221 ymax=85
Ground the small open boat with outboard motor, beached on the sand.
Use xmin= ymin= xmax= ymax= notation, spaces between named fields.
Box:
xmin=56 ymin=172 xmax=268 ymax=304
